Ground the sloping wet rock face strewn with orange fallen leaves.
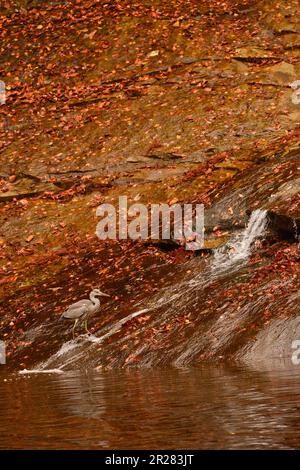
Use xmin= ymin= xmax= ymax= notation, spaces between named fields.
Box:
xmin=0 ymin=0 xmax=300 ymax=368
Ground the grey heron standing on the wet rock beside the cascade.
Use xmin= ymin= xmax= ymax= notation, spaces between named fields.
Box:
xmin=60 ymin=289 xmax=109 ymax=338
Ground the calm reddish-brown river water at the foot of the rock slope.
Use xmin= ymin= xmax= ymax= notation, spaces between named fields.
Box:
xmin=0 ymin=365 xmax=300 ymax=449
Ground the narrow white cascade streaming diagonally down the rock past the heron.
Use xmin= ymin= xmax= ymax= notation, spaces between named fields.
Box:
xmin=27 ymin=210 xmax=267 ymax=372
